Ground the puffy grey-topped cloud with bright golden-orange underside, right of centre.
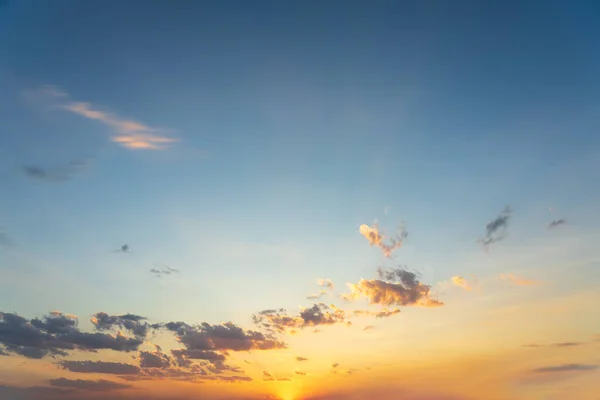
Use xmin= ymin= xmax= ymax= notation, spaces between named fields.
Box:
xmin=342 ymin=268 xmax=444 ymax=307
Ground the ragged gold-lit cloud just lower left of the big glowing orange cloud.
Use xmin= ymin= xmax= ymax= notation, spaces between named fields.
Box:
xmin=252 ymin=303 xmax=346 ymax=333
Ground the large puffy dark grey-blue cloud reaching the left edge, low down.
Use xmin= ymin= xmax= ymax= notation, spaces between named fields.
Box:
xmin=0 ymin=312 xmax=142 ymax=358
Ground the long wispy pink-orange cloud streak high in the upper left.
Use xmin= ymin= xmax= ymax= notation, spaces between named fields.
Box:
xmin=27 ymin=86 xmax=179 ymax=150
